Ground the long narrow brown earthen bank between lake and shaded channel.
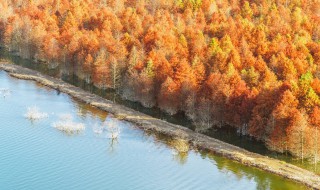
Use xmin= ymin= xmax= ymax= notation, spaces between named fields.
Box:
xmin=0 ymin=62 xmax=320 ymax=189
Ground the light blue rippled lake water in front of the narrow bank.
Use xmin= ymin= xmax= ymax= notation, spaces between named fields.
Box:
xmin=0 ymin=71 xmax=304 ymax=190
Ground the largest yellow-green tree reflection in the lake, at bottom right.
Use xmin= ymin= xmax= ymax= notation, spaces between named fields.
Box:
xmin=200 ymin=151 xmax=305 ymax=190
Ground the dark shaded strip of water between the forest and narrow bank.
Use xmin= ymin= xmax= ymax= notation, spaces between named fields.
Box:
xmin=0 ymin=47 xmax=320 ymax=174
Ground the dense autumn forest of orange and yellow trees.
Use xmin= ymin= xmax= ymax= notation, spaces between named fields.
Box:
xmin=0 ymin=0 xmax=320 ymax=161
